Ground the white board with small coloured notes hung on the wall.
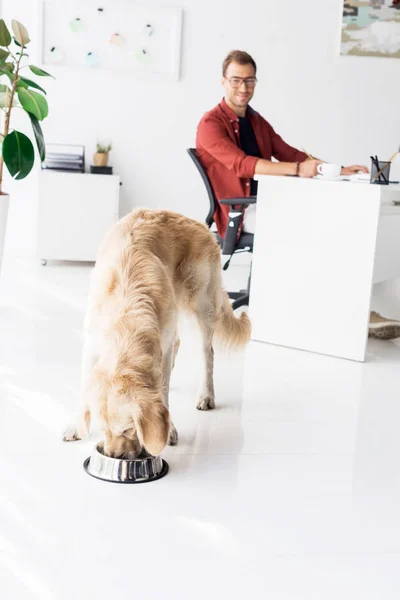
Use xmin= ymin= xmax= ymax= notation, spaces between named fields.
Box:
xmin=39 ymin=0 xmax=182 ymax=80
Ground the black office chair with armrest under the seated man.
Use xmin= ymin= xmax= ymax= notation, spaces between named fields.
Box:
xmin=187 ymin=148 xmax=257 ymax=310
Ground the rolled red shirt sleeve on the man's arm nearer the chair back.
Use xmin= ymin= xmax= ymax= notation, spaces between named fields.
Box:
xmin=197 ymin=116 xmax=259 ymax=178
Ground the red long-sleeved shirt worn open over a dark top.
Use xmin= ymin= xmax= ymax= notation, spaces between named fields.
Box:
xmin=196 ymin=100 xmax=307 ymax=237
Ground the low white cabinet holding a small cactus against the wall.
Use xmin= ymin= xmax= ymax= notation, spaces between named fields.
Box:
xmin=37 ymin=171 xmax=120 ymax=261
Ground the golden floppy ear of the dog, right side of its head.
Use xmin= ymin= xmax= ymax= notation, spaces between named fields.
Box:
xmin=134 ymin=400 xmax=170 ymax=456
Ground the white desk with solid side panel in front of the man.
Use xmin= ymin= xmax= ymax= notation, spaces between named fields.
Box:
xmin=250 ymin=176 xmax=400 ymax=361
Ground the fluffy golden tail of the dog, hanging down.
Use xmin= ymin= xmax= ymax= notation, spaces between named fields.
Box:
xmin=214 ymin=290 xmax=251 ymax=348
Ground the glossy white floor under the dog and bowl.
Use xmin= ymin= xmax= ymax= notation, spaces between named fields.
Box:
xmin=0 ymin=259 xmax=400 ymax=600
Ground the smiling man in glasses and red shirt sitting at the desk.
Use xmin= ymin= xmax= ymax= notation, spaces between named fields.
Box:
xmin=196 ymin=50 xmax=400 ymax=339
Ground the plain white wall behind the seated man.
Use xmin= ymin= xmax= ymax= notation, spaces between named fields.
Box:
xmin=3 ymin=0 xmax=400 ymax=255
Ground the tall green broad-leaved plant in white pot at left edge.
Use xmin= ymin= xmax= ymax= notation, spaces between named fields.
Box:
xmin=0 ymin=19 xmax=51 ymax=270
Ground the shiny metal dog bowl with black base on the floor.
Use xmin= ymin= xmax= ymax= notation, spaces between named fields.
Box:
xmin=83 ymin=442 xmax=169 ymax=483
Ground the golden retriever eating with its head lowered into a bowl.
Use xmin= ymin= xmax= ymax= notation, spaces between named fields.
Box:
xmin=63 ymin=209 xmax=250 ymax=458
